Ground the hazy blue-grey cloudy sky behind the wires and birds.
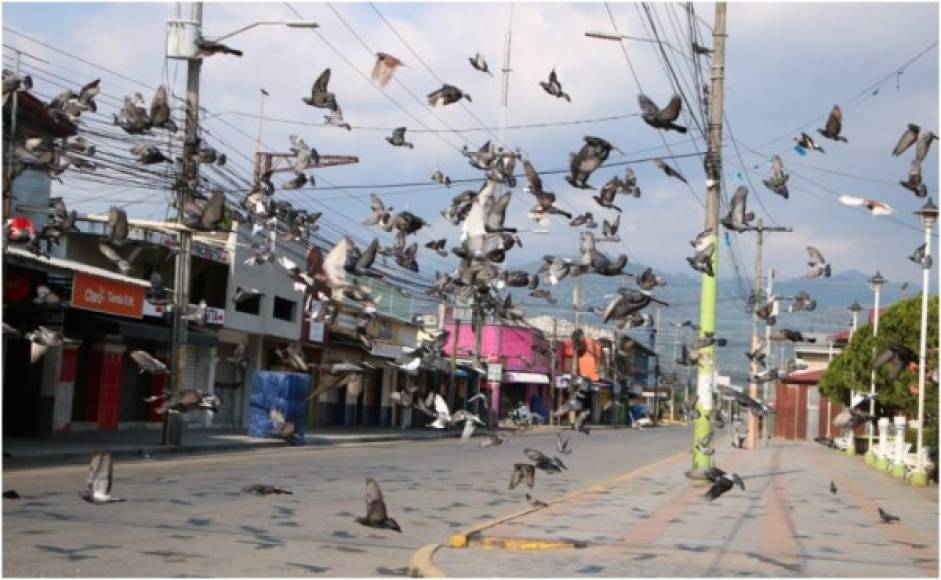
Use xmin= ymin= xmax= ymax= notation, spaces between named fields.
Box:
xmin=2 ymin=2 xmax=938 ymax=288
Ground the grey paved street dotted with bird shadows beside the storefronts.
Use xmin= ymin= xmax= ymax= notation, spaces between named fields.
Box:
xmin=3 ymin=427 xmax=689 ymax=576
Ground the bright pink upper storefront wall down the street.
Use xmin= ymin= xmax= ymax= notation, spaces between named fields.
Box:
xmin=444 ymin=322 xmax=550 ymax=374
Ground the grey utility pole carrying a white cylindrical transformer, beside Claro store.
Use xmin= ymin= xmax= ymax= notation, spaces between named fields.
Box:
xmin=163 ymin=2 xmax=203 ymax=446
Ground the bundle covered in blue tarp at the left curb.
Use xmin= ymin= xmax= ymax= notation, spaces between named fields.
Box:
xmin=248 ymin=371 xmax=310 ymax=445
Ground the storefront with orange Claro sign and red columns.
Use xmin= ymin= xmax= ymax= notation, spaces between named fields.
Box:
xmin=4 ymin=248 xmax=154 ymax=435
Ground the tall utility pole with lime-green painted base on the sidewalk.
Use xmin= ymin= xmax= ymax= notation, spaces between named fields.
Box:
xmin=687 ymin=2 xmax=727 ymax=479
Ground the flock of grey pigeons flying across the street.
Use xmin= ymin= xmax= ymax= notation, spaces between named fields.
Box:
xmin=3 ymin=20 xmax=938 ymax=531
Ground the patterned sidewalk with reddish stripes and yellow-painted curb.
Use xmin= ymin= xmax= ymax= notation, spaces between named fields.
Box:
xmin=415 ymin=441 xmax=938 ymax=577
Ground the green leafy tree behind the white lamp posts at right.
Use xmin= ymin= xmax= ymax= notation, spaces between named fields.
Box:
xmin=819 ymin=295 xmax=938 ymax=465
